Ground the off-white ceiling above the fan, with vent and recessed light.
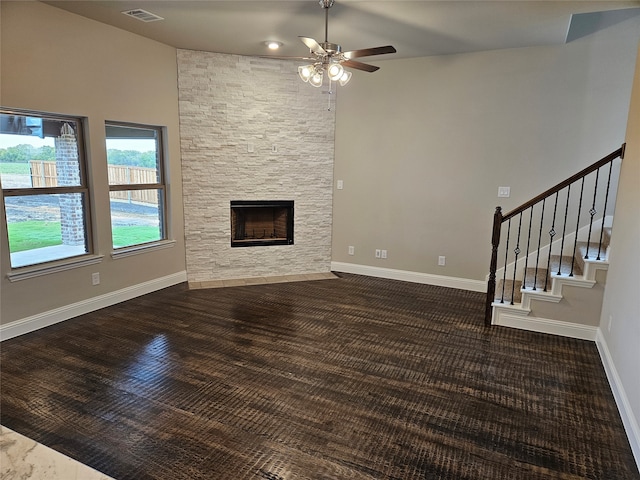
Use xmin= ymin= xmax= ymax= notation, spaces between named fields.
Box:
xmin=44 ymin=0 xmax=640 ymax=63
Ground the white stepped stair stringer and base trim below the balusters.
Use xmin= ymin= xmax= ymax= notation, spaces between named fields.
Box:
xmin=491 ymin=251 xmax=609 ymax=341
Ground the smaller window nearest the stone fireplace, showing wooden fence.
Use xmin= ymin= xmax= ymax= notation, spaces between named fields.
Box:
xmin=106 ymin=123 xmax=167 ymax=251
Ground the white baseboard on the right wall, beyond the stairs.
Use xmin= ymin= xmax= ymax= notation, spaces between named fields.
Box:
xmin=596 ymin=329 xmax=640 ymax=470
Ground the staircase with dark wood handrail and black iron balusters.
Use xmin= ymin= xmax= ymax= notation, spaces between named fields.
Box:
xmin=485 ymin=145 xmax=624 ymax=340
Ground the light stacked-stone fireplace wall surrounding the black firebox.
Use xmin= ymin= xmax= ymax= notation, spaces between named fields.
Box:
xmin=178 ymin=50 xmax=335 ymax=281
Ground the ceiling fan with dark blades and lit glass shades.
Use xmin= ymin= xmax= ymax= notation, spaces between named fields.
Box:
xmin=290 ymin=0 xmax=396 ymax=87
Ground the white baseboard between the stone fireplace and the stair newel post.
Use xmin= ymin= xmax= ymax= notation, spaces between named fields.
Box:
xmin=331 ymin=262 xmax=487 ymax=292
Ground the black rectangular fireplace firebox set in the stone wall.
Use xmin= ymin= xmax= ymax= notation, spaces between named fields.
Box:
xmin=231 ymin=200 xmax=293 ymax=247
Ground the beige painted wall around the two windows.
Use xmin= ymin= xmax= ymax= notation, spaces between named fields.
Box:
xmin=0 ymin=2 xmax=185 ymax=325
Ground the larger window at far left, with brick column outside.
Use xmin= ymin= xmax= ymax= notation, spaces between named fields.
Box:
xmin=0 ymin=109 xmax=92 ymax=268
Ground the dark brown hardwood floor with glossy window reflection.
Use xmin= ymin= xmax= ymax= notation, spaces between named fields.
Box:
xmin=0 ymin=274 xmax=640 ymax=480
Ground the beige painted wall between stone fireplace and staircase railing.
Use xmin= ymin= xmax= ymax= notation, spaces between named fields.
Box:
xmin=332 ymin=17 xmax=640 ymax=281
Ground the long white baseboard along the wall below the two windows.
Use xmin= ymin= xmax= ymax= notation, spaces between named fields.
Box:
xmin=0 ymin=271 xmax=187 ymax=342
